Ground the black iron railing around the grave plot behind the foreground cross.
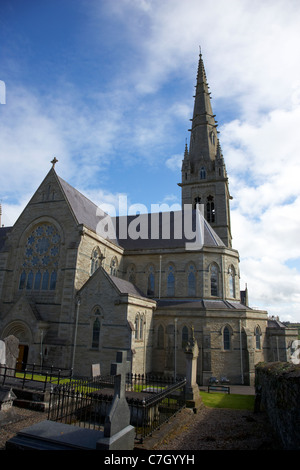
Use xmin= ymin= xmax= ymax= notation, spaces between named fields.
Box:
xmin=48 ymin=374 xmax=186 ymax=441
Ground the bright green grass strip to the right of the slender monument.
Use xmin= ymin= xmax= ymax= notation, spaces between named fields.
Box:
xmin=200 ymin=391 xmax=255 ymax=411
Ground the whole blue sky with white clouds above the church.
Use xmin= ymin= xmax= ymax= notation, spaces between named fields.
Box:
xmin=0 ymin=0 xmax=300 ymax=321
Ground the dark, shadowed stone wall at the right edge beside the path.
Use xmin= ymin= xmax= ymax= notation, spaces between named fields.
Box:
xmin=255 ymin=362 xmax=300 ymax=450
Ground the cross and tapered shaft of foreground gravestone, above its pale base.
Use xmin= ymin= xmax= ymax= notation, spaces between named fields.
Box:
xmin=104 ymin=351 xmax=130 ymax=437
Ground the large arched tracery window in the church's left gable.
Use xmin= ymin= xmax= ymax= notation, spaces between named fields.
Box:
xmin=19 ymin=222 xmax=60 ymax=291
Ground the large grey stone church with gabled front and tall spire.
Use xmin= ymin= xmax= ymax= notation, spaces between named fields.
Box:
xmin=0 ymin=54 xmax=296 ymax=385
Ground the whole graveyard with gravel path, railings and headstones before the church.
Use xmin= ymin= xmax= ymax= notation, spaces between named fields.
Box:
xmin=0 ymin=336 xmax=300 ymax=451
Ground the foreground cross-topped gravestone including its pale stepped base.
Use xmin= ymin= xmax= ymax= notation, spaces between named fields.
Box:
xmin=97 ymin=351 xmax=135 ymax=450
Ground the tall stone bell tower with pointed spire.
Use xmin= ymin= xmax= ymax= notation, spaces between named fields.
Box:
xmin=179 ymin=53 xmax=232 ymax=247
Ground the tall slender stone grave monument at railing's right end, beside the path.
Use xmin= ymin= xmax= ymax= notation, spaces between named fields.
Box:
xmin=185 ymin=329 xmax=203 ymax=412
